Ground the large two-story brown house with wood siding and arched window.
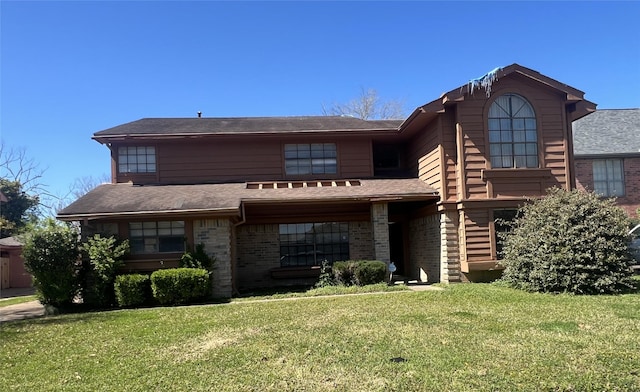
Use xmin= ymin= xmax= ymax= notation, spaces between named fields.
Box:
xmin=58 ymin=64 xmax=595 ymax=296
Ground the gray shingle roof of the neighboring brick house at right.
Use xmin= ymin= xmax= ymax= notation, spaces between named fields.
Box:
xmin=573 ymin=109 xmax=640 ymax=156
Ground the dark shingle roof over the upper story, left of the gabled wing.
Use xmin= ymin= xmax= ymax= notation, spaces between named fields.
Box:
xmin=94 ymin=116 xmax=402 ymax=140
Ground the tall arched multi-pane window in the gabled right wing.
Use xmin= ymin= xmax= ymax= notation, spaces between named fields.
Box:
xmin=489 ymin=94 xmax=538 ymax=168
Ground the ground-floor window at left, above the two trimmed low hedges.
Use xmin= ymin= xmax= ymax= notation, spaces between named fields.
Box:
xmin=129 ymin=221 xmax=185 ymax=254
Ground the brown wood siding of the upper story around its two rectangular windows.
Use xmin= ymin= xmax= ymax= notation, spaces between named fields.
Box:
xmin=112 ymin=136 xmax=373 ymax=184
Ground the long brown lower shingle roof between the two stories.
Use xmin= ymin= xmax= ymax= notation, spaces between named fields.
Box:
xmin=58 ymin=178 xmax=437 ymax=220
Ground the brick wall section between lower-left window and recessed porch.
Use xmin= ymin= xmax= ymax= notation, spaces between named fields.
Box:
xmin=193 ymin=219 xmax=233 ymax=298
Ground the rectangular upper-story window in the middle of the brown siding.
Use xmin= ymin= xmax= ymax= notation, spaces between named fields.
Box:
xmin=284 ymin=143 xmax=338 ymax=175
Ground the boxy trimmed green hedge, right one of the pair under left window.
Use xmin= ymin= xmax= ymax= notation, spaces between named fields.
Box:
xmin=151 ymin=268 xmax=211 ymax=305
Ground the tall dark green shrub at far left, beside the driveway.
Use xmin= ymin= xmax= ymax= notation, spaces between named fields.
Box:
xmin=22 ymin=219 xmax=80 ymax=307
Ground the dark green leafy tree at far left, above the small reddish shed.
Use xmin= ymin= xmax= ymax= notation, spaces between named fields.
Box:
xmin=0 ymin=178 xmax=39 ymax=238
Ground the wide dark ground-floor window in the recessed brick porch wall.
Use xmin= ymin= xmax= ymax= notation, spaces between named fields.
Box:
xmin=280 ymin=222 xmax=349 ymax=267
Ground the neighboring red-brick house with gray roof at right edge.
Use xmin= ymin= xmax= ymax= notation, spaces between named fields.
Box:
xmin=573 ymin=109 xmax=640 ymax=217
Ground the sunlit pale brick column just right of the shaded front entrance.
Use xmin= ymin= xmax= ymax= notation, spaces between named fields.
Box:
xmin=440 ymin=211 xmax=461 ymax=283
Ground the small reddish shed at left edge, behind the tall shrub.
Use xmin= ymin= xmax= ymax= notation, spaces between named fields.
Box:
xmin=0 ymin=237 xmax=32 ymax=289
